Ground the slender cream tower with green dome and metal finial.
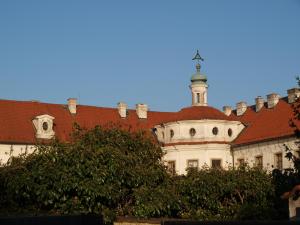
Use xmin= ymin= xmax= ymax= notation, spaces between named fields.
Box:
xmin=190 ymin=50 xmax=208 ymax=106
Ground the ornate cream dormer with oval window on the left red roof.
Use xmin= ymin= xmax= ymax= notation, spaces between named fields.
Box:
xmin=32 ymin=114 xmax=55 ymax=139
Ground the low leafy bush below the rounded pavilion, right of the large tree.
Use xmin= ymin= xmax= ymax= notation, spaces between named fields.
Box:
xmin=178 ymin=167 xmax=276 ymax=220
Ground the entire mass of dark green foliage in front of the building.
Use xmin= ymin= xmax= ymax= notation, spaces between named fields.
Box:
xmin=0 ymin=125 xmax=284 ymax=221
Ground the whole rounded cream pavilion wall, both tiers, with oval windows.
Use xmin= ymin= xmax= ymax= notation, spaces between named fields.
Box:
xmin=156 ymin=119 xmax=244 ymax=174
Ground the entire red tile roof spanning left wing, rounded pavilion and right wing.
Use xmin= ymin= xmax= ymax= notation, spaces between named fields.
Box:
xmin=0 ymin=99 xmax=294 ymax=145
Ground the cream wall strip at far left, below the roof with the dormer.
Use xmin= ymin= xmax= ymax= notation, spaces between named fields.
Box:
xmin=0 ymin=144 xmax=35 ymax=164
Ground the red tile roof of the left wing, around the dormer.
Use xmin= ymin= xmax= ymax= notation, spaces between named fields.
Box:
xmin=0 ymin=100 xmax=173 ymax=144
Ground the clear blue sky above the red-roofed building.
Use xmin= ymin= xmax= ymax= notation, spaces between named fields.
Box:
xmin=0 ymin=0 xmax=300 ymax=111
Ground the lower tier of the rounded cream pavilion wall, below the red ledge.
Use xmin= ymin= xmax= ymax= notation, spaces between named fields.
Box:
xmin=163 ymin=144 xmax=232 ymax=174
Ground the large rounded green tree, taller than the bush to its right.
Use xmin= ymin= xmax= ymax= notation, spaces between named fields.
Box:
xmin=0 ymin=125 xmax=176 ymax=220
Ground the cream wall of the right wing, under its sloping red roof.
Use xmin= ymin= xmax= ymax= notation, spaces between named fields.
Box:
xmin=232 ymin=137 xmax=298 ymax=170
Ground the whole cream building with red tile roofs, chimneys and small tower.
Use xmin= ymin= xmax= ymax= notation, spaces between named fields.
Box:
xmin=0 ymin=52 xmax=300 ymax=174
